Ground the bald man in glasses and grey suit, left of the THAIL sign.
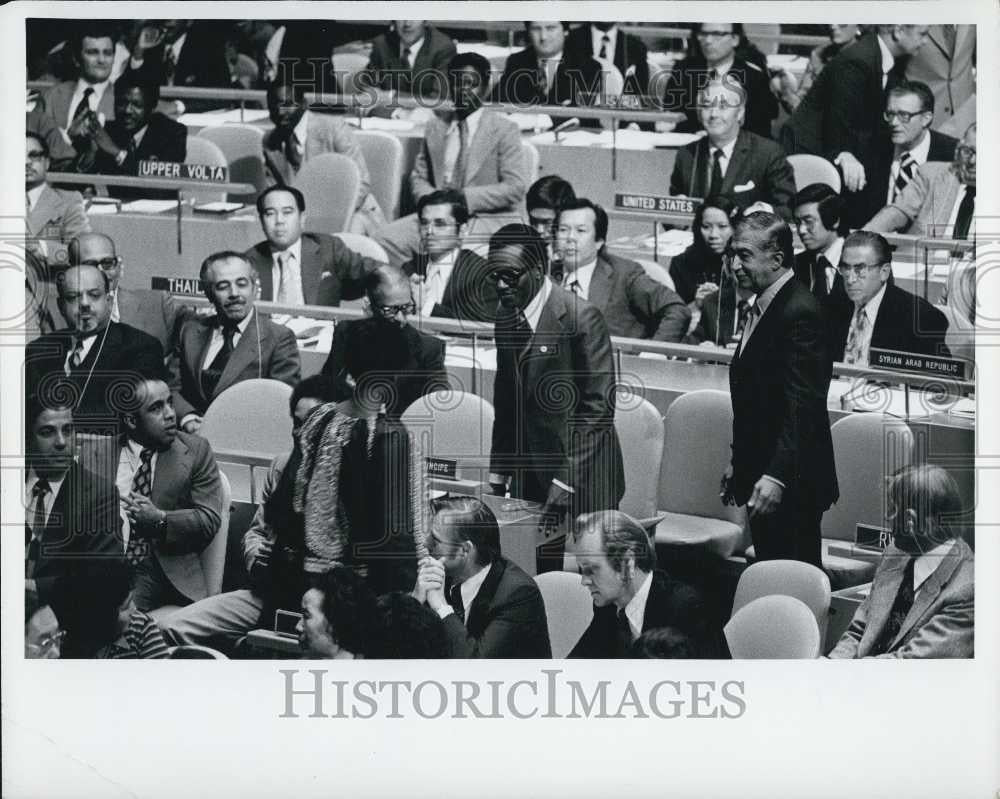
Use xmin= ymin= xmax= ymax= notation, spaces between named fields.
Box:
xmin=69 ymin=233 xmax=188 ymax=357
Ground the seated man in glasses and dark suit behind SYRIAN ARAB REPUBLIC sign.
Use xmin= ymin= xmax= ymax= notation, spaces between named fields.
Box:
xmin=830 ymin=230 xmax=949 ymax=366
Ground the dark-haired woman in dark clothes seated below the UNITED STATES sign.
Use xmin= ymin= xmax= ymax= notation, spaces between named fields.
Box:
xmin=670 ymin=195 xmax=741 ymax=313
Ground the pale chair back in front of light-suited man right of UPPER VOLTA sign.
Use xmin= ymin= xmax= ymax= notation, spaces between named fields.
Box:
xmin=295 ymin=153 xmax=361 ymax=233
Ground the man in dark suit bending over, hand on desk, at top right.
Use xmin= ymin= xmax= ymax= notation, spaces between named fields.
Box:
xmin=781 ymin=25 xmax=927 ymax=200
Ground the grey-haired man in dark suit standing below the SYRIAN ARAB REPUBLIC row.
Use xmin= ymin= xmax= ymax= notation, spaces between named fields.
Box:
xmin=720 ymin=212 xmax=839 ymax=568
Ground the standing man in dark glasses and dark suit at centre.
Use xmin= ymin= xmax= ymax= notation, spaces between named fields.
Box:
xmin=489 ymin=224 xmax=625 ymax=573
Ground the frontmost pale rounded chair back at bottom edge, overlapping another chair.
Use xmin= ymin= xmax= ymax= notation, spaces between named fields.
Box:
xmin=723 ymin=594 xmax=820 ymax=660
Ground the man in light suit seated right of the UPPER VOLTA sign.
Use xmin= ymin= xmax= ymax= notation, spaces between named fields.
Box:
xmin=264 ymin=82 xmax=385 ymax=236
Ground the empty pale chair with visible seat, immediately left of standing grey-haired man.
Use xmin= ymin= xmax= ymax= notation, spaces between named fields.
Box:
xmin=655 ymin=389 xmax=749 ymax=558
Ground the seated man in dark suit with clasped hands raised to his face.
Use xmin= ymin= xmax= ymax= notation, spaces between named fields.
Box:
xmin=413 ymin=497 xmax=552 ymax=658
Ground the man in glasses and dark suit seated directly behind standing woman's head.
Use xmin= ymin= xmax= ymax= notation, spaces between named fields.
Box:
xmin=323 ymin=266 xmax=449 ymax=417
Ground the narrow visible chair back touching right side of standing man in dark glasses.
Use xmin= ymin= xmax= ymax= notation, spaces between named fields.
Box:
xmin=615 ymin=395 xmax=663 ymax=519
